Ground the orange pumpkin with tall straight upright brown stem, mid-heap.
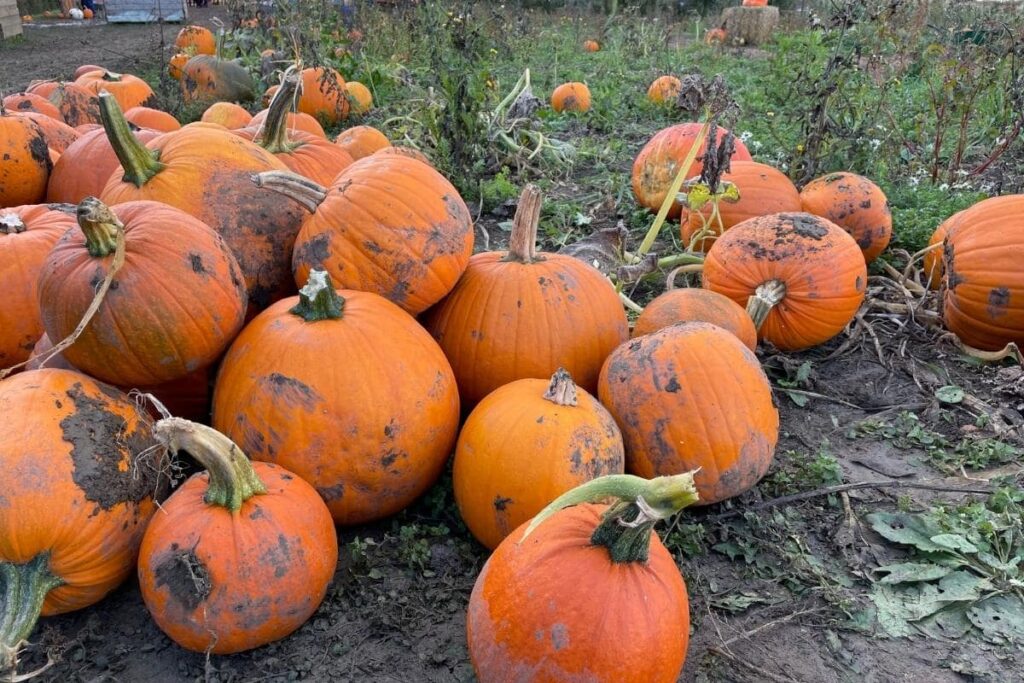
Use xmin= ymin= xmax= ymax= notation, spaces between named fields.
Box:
xmin=421 ymin=184 xmax=629 ymax=407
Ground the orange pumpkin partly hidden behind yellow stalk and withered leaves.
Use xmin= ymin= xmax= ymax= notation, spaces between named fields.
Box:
xmin=679 ymin=161 xmax=801 ymax=252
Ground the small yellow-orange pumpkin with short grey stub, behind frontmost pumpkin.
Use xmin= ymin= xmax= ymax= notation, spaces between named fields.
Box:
xmin=452 ymin=370 xmax=626 ymax=549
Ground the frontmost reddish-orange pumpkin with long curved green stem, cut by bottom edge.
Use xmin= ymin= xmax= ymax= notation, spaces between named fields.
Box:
xmin=466 ymin=474 xmax=697 ymax=683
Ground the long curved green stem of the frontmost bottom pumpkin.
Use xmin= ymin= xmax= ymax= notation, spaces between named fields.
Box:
xmin=519 ymin=471 xmax=699 ymax=563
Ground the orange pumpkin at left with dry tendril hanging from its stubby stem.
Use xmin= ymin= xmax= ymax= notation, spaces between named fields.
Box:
xmin=39 ymin=198 xmax=246 ymax=386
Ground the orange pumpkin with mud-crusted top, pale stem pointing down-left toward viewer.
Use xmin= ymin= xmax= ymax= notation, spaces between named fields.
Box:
xmin=703 ymin=213 xmax=867 ymax=351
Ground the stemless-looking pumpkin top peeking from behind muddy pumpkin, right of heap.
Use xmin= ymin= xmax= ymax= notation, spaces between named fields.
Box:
xmin=633 ymin=288 xmax=758 ymax=351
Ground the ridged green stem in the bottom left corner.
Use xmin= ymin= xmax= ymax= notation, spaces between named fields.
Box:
xmin=0 ymin=553 xmax=63 ymax=673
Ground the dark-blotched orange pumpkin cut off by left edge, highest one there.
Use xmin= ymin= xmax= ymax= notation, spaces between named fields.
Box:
xmin=0 ymin=102 xmax=53 ymax=209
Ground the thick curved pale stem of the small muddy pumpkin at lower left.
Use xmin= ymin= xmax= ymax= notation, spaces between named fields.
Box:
xmin=153 ymin=418 xmax=266 ymax=512
